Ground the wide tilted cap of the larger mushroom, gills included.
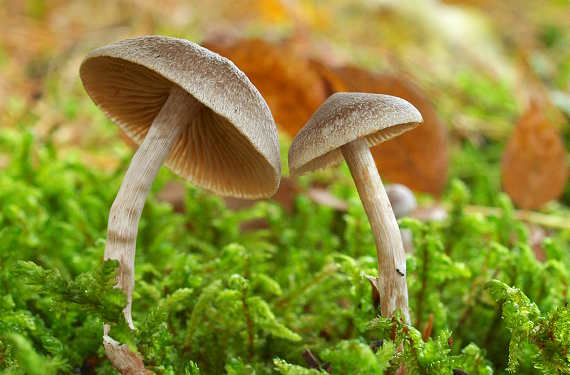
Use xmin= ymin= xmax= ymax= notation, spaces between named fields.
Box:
xmin=80 ymin=36 xmax=281 ymax=199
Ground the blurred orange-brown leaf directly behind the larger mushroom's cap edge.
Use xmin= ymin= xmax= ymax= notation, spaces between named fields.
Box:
xmin=203 ymin=39 xmax=327 ymax=136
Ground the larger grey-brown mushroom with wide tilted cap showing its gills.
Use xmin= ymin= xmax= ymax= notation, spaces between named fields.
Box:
xmin=80 ymin=36 xmax=281 ymax=328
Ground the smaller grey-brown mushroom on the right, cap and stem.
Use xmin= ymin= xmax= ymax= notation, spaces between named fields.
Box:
xmin=289 ymin=93 xmax=422 ymax=322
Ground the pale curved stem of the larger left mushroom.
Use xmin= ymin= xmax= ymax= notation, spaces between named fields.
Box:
xmin=104 ymin=87 xmax=202 ymax=329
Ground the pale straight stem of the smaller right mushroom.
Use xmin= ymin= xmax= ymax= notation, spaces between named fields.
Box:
xmin=341 ymin=139 xmax=410 ymax=323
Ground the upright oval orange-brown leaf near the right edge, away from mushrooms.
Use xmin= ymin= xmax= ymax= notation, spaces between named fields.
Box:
xmin=501 ymin=102 xmax=568 ymax=209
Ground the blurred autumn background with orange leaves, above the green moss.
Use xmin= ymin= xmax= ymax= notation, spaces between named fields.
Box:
xmin=0 ymin=0 xmax=570 ymax=212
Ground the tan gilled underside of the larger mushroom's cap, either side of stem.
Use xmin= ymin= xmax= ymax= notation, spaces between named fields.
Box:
xmin=81 ymin=57 xmax=275 ymax=198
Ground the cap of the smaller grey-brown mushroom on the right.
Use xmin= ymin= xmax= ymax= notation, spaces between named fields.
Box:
xmin=289 ymin=92 xmax=422 ymax=176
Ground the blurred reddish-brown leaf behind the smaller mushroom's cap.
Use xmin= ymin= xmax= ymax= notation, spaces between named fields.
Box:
xmin=317 ymin=67 xmax=448 ymax=195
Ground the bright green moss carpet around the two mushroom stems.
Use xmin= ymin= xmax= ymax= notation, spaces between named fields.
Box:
xmin=0 ymin=130 xmax=570 ymax=374
